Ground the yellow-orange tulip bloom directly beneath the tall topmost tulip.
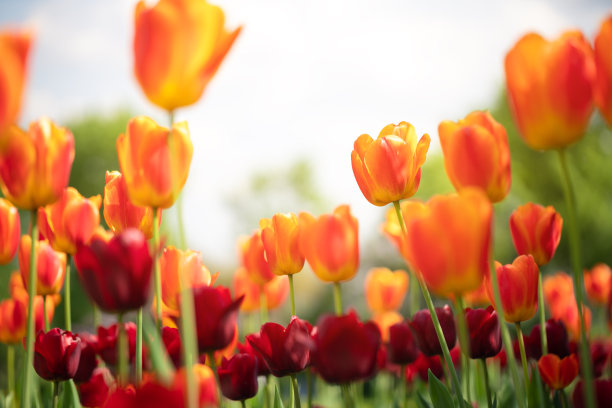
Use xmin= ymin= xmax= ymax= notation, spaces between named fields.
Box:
xmin=117 ymin=116 xmax=193 ymax=208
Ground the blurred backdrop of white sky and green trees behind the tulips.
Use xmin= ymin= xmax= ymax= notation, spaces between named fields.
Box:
xmin=0 ymin=0 xmax=612 ymax=322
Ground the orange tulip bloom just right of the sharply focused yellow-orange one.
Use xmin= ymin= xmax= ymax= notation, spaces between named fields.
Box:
xmin=438 ymin=111 xmax=511 ymax=203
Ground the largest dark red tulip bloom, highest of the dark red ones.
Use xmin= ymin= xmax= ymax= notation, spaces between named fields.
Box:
xmin=74 ymin=229 xmax=153 ymax=313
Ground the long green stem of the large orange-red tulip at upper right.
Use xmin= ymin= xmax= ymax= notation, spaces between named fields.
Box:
xmin=560 ymin=149 xmax=595 ymax=408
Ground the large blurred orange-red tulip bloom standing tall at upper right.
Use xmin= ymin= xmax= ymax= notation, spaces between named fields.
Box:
xmin=505 ymin=31 xmax=596 ymax=150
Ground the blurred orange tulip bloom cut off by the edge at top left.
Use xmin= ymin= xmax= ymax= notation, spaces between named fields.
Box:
xmin=0 ymin=31 xmax=32 ymax=129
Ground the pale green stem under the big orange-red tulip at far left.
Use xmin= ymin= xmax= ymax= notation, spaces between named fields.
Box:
xmin=21 ymin=210 xmax=38 ymax=408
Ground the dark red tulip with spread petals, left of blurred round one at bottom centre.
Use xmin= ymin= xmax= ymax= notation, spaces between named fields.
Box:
xmin=246 ymin=316 xmax=311 ymax=377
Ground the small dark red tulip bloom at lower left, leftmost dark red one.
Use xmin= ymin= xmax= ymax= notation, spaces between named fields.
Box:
xmin=34 ymin=328 xmax=81 ymax=381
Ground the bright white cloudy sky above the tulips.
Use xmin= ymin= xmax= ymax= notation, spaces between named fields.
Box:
xmin=0 ymin=0 xmax=612 ymax=263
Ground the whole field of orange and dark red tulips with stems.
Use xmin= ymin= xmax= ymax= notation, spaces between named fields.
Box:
xmin=0 ymin=0 xmax=612 ymax=408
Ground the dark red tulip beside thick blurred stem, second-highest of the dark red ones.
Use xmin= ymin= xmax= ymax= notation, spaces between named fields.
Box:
xmin=193 ymin=286 xmax=244 ymax=353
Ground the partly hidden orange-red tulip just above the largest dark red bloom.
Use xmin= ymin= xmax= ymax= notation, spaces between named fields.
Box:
xmin=103 ymin=171 xmax=162 ymax=239
